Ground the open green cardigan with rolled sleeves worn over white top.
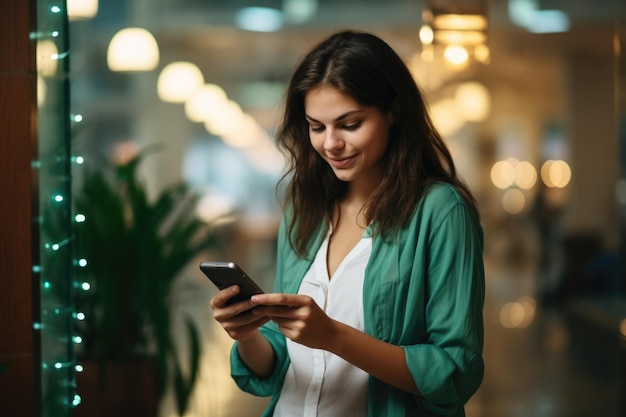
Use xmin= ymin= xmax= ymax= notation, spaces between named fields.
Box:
xmin=231 ymin=184 xmax=485 ymax=417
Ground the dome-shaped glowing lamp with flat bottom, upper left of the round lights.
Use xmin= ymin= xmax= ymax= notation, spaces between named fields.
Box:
xmin=107 ymin=28 xmax=159 ymax=72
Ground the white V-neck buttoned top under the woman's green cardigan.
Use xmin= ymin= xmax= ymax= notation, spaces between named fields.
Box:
xmin=274 ymin=233 xmax=372 ymax=417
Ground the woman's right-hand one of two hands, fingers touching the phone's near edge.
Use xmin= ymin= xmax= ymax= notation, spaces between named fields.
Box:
xmin=250 ymin=294 xmax=336 ymax=349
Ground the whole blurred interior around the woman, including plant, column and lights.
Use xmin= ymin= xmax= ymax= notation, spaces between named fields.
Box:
xmin=0 ymin=0 xmax=626 ymax=417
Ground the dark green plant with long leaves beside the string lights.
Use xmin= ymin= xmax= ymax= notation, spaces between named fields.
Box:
xmin=74 ymin=148 xmax=224 ymax=416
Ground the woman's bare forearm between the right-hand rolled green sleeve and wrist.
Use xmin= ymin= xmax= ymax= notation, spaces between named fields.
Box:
xmin=325 ymin=321 xmax=420 ymax=395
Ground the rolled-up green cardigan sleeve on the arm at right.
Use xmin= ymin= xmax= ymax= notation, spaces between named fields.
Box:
xmin=404 ymin=203 xmax=484 ymax=416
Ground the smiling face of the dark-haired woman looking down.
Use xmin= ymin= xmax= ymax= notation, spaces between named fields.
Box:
xmin=304 ymin=86 xmax=392 ymax=186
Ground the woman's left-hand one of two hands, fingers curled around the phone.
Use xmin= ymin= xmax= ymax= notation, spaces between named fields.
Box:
xmin=210 ymin=285 xmax=270 ymax=341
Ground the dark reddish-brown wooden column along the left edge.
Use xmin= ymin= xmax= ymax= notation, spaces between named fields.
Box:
xmin=0 ymin=0 xmax=41 ymax=416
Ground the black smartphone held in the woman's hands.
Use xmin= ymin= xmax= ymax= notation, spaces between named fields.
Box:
xmin=200 ymin=261 xmax=263 ymax=304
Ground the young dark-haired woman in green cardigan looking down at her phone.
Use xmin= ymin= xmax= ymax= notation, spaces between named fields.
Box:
xmin=211 ymin=31 xmax=484 ymax=417
